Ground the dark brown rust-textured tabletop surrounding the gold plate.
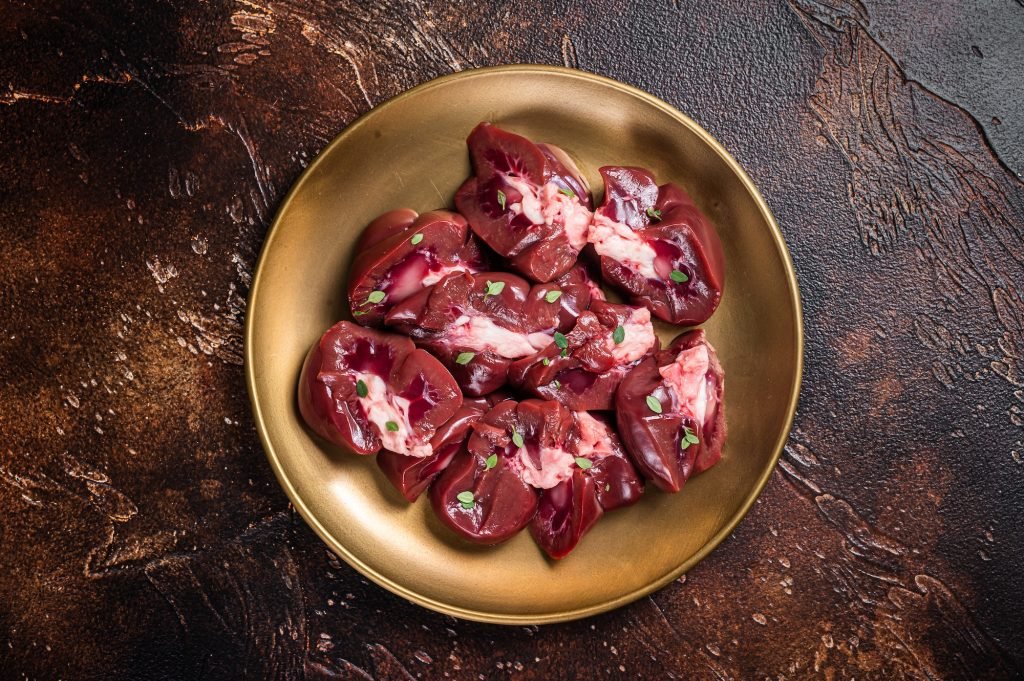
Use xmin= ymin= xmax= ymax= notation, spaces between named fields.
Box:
xmin=0 ymin=0 xmax=1024 ymax=680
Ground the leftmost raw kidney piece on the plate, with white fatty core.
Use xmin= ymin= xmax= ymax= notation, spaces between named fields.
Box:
xmin=298 ymin=322 xmax=462 ymax=458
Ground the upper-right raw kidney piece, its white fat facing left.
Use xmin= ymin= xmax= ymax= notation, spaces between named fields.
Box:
xmin=588 ymin=166 xmax=725 ymax=326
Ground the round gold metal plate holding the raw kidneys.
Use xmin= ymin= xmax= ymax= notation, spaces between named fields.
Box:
xmin=246 ymin=66 xmax=803 ymax=625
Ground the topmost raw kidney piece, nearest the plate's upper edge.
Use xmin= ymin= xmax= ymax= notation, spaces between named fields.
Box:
xmin=455 ymin=123 xmax=593 ymax=282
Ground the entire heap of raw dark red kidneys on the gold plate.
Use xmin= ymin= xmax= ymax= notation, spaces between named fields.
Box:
xmin=299 ymin=123 xmax=726 ymax=559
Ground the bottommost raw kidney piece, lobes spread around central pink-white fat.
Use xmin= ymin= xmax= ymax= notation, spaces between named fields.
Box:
xmin=430 ymin=399 xmax=643 ymax=558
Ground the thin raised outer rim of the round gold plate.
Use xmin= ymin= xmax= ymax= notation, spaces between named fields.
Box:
xmin=244 ymin=63 xmax=804 ymax=626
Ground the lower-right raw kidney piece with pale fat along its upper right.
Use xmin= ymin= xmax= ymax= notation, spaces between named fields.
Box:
xmin=615 ymin=330 xmax=726 ymax=492
